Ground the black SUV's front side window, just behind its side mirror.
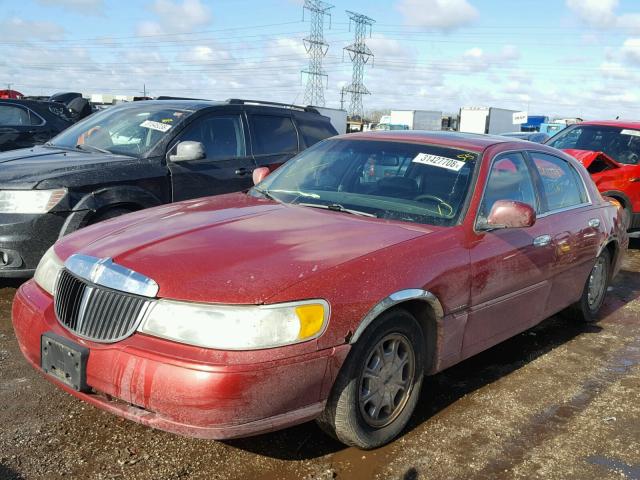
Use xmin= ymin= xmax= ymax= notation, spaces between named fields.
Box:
xmin=180 ymin=115 xmax=246 ymax=160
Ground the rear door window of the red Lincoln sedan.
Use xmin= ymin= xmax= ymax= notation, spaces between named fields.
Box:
xmin=531 ymin=152 xmax=588 ymax=211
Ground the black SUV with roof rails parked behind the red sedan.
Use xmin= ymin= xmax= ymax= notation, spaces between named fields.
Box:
xmin=0 ymin=100 xmax=337 ymax=277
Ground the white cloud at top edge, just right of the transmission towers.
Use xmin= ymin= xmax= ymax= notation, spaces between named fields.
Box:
xmin=396 ymin=0 xmax=478 ymax=31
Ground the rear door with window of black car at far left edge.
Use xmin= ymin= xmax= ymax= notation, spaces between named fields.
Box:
xmin=0 ymin=102 xmax=48 ymax=150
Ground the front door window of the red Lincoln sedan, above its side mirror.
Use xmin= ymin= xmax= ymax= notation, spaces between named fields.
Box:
xmin=480 ymin=153 xmax=537 ymax=218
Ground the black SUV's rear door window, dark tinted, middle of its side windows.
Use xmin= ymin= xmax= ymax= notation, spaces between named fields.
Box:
xmin=250 ymin=115 xmax=298 ymax=155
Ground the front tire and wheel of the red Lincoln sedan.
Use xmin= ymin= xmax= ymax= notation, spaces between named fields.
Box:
xmin=317 ymin=309 xmax=425 ymax=449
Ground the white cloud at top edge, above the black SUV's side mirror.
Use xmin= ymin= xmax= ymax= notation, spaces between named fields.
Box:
xmin=138 ymin=0 xmax=213 ymax=35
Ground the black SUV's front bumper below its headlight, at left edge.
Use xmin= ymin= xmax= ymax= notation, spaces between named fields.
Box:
xmin=0 ymin=212 xmax=68 ymax=278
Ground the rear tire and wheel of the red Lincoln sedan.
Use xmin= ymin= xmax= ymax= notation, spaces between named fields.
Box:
xmin=570 ymin=249 xmax=611 ymax=323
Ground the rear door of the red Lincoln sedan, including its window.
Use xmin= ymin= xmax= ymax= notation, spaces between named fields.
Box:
xmin=528 ymin=151 xmax=603 ymax=316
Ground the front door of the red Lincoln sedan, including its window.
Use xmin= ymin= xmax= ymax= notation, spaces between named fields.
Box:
xmin=462 ymin=153 xmax=554 ymax=358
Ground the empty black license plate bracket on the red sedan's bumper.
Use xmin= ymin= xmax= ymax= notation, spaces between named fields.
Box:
xmin=40 ymin=332 xmax=89 ymax=392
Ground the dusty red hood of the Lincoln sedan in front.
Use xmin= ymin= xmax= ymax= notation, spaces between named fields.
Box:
xmin=56 ymin=194 xmax=432 ymax=304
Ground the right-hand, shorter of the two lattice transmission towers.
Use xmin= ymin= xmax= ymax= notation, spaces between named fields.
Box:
xmin=344 ymin=10 xmax=375 ymax=120
